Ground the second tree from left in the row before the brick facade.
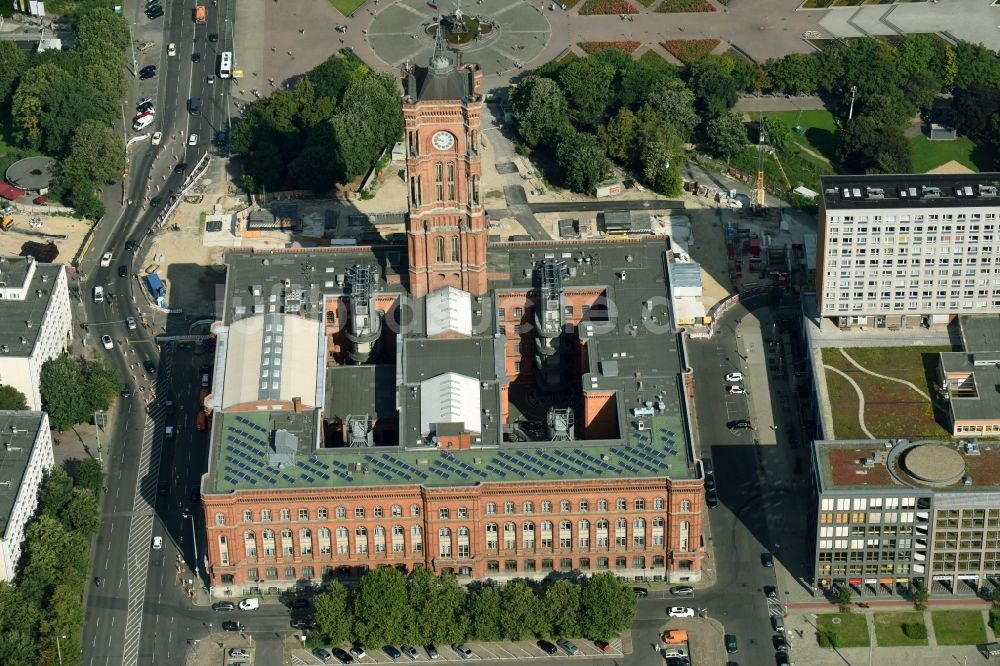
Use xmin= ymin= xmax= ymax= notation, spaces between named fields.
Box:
xmin=354 ymin=567 xmax=413 ymax=647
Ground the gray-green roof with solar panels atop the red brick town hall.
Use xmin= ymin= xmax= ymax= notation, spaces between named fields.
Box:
xmin=206 ymin=239 xmax=698 ymax=492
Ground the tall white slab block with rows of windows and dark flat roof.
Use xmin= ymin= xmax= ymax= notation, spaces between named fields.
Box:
xmin=817 ymin=173 xmax=1000 ymax=329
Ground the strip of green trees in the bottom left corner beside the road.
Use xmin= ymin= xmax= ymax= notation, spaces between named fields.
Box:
xmin=0 ymin=459 xmax=104 ymax=666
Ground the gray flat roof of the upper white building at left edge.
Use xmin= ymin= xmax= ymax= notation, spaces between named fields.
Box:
xmin=0 ymin=257 xmax=64 ymax=356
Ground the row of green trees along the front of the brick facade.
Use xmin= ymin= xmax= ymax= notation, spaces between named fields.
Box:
xmin=312 ymin=568 xmax=637 ymax=647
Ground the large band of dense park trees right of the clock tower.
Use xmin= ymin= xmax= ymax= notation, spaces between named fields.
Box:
xmin=510 ymin=35 xmax=1000 ymax=195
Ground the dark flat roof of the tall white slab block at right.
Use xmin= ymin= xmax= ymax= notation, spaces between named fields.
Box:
xmin=820 ymin=173 xmax=1000 ymax=211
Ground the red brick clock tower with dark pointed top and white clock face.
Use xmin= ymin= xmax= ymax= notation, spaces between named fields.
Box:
xmin=402 ymin=30 xmax=487 ymax=296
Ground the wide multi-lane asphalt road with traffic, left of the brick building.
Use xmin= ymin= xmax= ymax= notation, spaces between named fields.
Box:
xmin=82 ymin=0 xmax=236 ymax=664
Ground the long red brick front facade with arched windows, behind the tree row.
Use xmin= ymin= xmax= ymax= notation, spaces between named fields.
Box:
xmin=204 ymin=478 xmax=702 ymax=596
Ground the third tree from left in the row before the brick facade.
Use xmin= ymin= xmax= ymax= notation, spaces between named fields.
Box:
xmin=409 ymin=567 xmax=468 ymax=645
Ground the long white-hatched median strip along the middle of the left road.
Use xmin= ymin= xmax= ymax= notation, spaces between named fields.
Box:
xmin=119 ymin=363 xmax=170 ymax=666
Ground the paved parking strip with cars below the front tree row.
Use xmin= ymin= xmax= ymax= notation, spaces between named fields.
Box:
xmin=292 ymin=638 xmax=623 ymax=666
